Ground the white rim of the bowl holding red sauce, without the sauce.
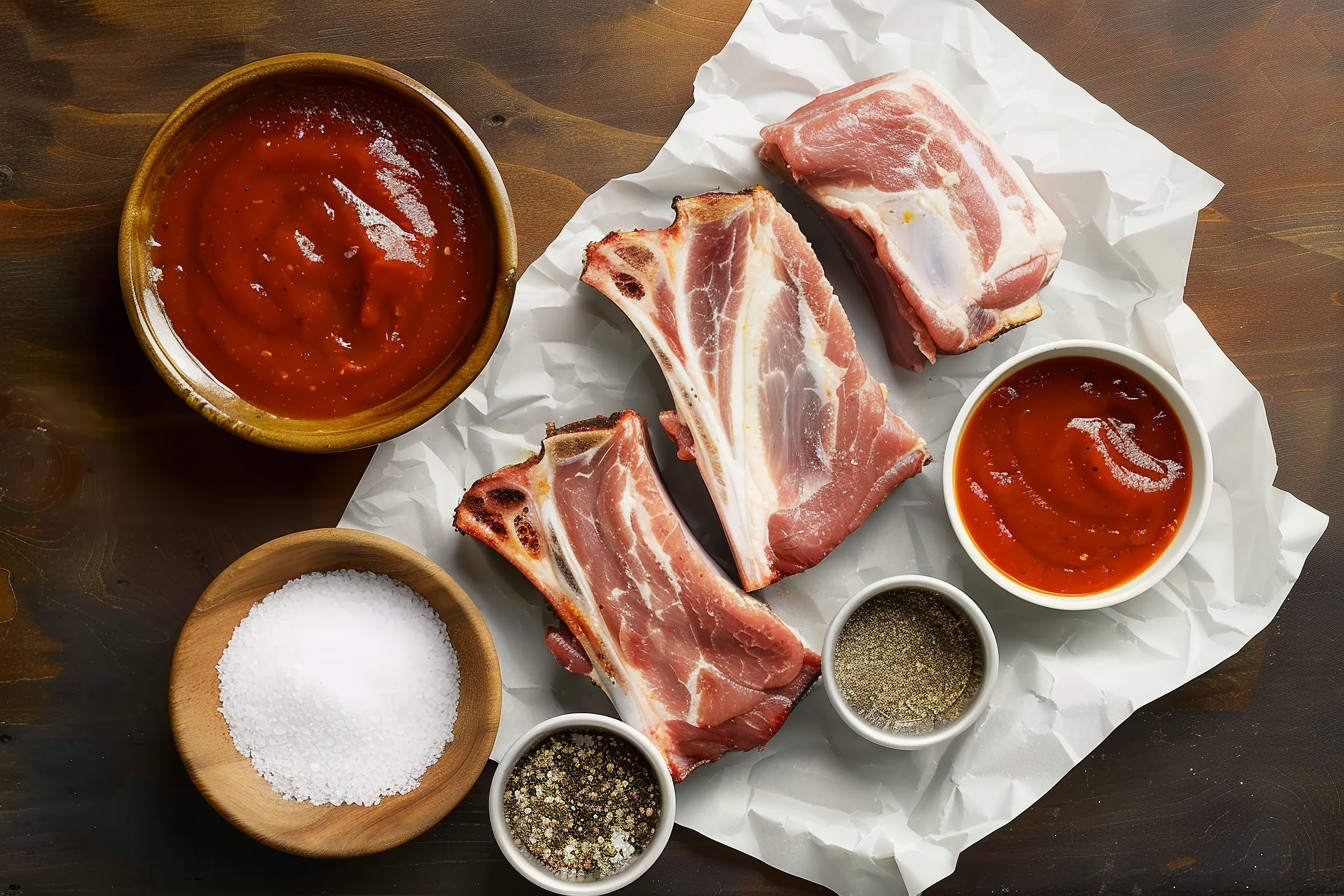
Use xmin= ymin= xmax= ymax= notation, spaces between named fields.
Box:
xmin=942 ymin=339 xmax=1214 ymax=610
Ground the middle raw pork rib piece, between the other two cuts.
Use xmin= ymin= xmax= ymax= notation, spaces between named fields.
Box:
xmin=583 ymin=187 xmax=929 ymax=591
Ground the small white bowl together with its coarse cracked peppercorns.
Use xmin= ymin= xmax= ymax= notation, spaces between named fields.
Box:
xmin=489 ymin=712 xmax=676 ymax=896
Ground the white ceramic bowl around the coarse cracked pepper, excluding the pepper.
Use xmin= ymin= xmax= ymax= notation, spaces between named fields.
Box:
xmin=489 ymin=712 xmax=676 ymax=896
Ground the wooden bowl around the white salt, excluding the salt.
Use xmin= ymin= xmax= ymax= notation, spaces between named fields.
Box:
xmin=168 ymin=529 xmax=500 ymax=858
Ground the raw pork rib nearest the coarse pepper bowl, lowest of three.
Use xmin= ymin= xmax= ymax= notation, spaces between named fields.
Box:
xmin=453 ymin=411 xmax=821 ymax=780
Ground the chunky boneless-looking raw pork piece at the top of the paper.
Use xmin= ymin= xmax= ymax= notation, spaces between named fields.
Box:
xmin=761 ymin=69 xmax=1064 ymax=371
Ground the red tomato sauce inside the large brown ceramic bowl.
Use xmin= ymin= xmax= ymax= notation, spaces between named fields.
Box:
xmin=151 ymin=82 xmax=496 ymax=419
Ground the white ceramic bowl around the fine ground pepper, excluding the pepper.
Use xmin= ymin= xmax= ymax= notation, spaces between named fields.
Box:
xmin=821 ymin=575 xmax=999 ymax=750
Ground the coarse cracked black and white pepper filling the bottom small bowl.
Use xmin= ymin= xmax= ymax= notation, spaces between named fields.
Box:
xmin=504 ymin=728 xmax=663 ymax=880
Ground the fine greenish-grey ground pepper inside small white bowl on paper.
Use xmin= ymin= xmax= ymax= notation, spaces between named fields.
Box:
xmin=835 ymin=588 xmax=985 ymax=735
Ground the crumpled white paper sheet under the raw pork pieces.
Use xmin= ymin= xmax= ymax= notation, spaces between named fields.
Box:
xmin=341 ymin=0 xmax=1325 ymax=895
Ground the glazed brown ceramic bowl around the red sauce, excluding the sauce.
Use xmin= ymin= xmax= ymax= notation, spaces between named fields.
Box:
xmin=118 ymin=52 xmax=517 ymax=451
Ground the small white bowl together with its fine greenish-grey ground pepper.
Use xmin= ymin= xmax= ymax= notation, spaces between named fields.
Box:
xmin=821 ymin=575 xmax=999 ymax=750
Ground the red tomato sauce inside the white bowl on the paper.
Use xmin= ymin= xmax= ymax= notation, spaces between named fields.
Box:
xmin=953 ymin=357 xmax=1191 ymax=595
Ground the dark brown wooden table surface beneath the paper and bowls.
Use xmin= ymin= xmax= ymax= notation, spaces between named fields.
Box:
xmin=0 ymin=0 xmax=1344 ymax=895
